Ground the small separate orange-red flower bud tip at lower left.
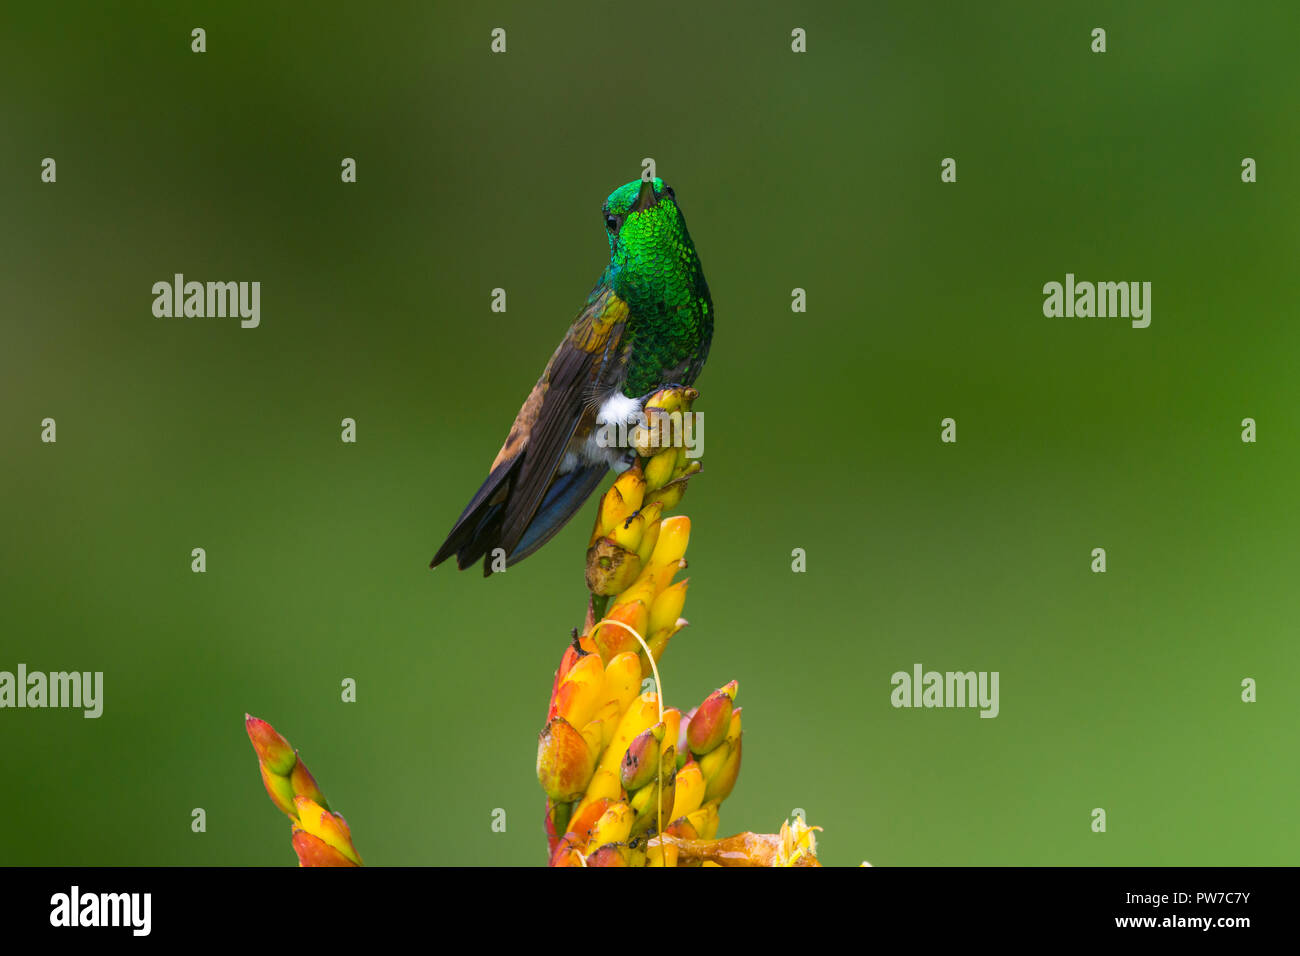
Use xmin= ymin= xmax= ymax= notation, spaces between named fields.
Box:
xmin=244 ymin=714 xmax=361 ymax=866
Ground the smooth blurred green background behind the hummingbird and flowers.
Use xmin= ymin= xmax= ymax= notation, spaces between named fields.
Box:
xmin=0 ymin=3 xmax=1300 ymax=865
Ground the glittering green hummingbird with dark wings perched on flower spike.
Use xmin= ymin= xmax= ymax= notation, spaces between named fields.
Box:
xmin=429 ymin=177 xmax=714 ymax=578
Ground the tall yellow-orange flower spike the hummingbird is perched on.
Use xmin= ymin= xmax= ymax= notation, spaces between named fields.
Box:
xmin=537 ymin=388 xmax=818 ymax=866
